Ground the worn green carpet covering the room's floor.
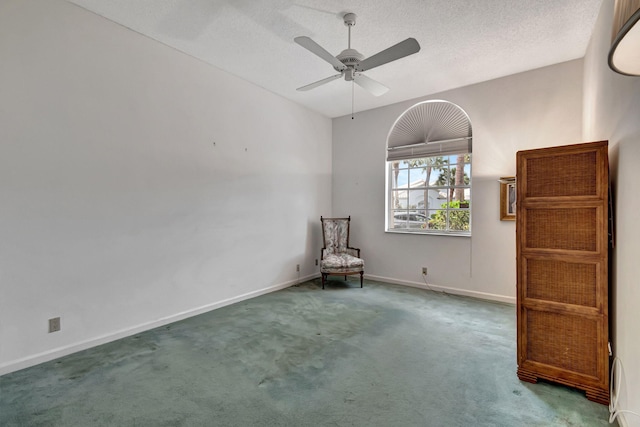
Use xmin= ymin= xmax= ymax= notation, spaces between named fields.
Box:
xmin=0 ymin=280 xmax=609 ymax=427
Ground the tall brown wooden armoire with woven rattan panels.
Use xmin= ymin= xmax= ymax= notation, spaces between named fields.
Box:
xmin=516 ymin=141 xmax=609 ymax=404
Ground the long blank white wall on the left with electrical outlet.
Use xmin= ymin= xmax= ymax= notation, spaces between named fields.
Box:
xmin=0 ymin=0 xmax=332 ymax=374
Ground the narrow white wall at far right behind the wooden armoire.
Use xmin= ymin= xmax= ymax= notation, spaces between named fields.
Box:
xmin=583 ymin=0 xmax=640 ymax=427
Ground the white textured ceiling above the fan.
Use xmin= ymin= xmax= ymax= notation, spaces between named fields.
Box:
xmin=68 ymin=0 xmax=608 ymax=117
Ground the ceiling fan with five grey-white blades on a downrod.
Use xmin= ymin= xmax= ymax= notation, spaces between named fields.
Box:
xmin=293 ymin=13 xmax=420 ymax=96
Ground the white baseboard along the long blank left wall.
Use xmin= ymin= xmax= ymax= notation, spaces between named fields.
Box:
xmin=0 ymin=273 xmax=319 ymax=375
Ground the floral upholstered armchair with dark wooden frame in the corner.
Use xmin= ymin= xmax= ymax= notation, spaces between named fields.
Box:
xmin=320 ymin=216 xmax=364 ymax=289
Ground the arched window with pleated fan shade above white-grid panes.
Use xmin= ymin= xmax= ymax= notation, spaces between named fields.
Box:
xmin=386 ymin=100 xmax=472 ymax=235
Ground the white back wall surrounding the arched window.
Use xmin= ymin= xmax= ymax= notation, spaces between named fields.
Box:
xmin=332 ymin=60 xmax=583 ymax=302
